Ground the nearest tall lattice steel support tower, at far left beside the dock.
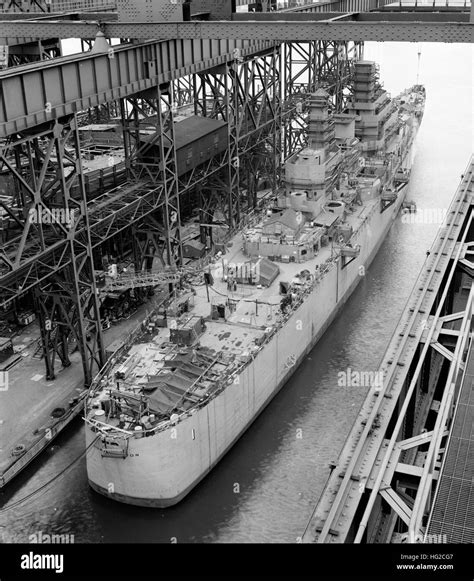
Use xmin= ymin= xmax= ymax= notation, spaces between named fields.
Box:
xmin=6 ymin=117 xmax=105 ymax=385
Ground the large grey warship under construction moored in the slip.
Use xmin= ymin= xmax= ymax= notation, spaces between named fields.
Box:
xmin=84 ymin=60 xmax=425 ymax=507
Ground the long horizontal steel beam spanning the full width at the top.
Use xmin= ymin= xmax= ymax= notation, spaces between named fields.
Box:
xmin=0 ymin=18 xmax=474 ymax=44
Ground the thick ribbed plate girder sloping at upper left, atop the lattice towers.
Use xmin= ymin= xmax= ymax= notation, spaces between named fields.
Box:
xmin=0 ymin=40 xmax=273 ymax=138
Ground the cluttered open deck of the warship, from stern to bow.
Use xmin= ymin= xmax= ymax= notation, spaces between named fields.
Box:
xmin=88 ymin=88 xmax=422 ymax=430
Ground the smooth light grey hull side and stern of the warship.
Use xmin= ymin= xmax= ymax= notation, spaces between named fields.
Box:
xmin=86 ymin=179 xmax=411 ymax=507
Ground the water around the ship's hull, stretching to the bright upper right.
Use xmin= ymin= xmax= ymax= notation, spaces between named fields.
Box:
xmin=0 ymin=43 xmax=474 ymax=543
